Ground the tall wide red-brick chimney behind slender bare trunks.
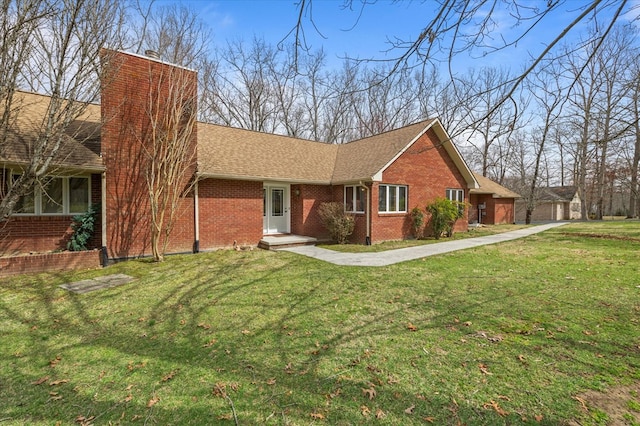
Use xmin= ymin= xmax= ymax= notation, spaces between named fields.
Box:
xmin=101 ymin=50 xmax=197 ymax=258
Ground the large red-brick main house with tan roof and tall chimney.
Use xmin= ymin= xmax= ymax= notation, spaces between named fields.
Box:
xmin=0 ymin=53 xmax=478 ymax=259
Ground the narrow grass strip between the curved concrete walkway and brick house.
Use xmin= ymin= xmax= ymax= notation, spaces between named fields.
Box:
xmin=318 ymin=224 xmax=531 ymax=253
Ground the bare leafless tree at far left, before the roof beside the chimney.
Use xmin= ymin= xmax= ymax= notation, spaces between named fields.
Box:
xmin=0 ymin=0 xmax=124 ymax=220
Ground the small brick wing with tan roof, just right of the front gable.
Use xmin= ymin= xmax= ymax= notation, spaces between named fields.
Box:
xmin=469 ymin=173 xmax=521 ymax=225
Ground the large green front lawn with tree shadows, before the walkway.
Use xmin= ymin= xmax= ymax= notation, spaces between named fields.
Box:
xmin=0 ymin=221 xmax=640 ymax=426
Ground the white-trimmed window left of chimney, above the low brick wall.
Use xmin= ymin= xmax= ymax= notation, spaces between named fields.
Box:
xmin=11 ymin=173 xmax=91 ymax=216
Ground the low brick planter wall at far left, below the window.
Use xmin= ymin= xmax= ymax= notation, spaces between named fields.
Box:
xmin=0 ymin=250 xmax=100 ymax=276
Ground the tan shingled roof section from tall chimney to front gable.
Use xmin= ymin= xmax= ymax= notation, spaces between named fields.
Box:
xmin=198 ymin=119 xmax=476 ymax=187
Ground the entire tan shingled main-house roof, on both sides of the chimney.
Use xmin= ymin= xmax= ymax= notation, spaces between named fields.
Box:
xmin=0 ymin=92 xmax=477 ymax=188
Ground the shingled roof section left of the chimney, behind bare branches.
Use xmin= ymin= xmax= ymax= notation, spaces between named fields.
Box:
xmin=0 ymin=92 xmax=104 ymax=171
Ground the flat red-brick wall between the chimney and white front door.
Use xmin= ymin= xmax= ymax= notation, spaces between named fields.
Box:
xmin=198 ymin=179 xmax=263 ymax=250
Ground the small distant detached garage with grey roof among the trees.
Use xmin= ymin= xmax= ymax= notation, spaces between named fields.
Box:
xmin=516 ymin=186 xmax=582 ymax=222
